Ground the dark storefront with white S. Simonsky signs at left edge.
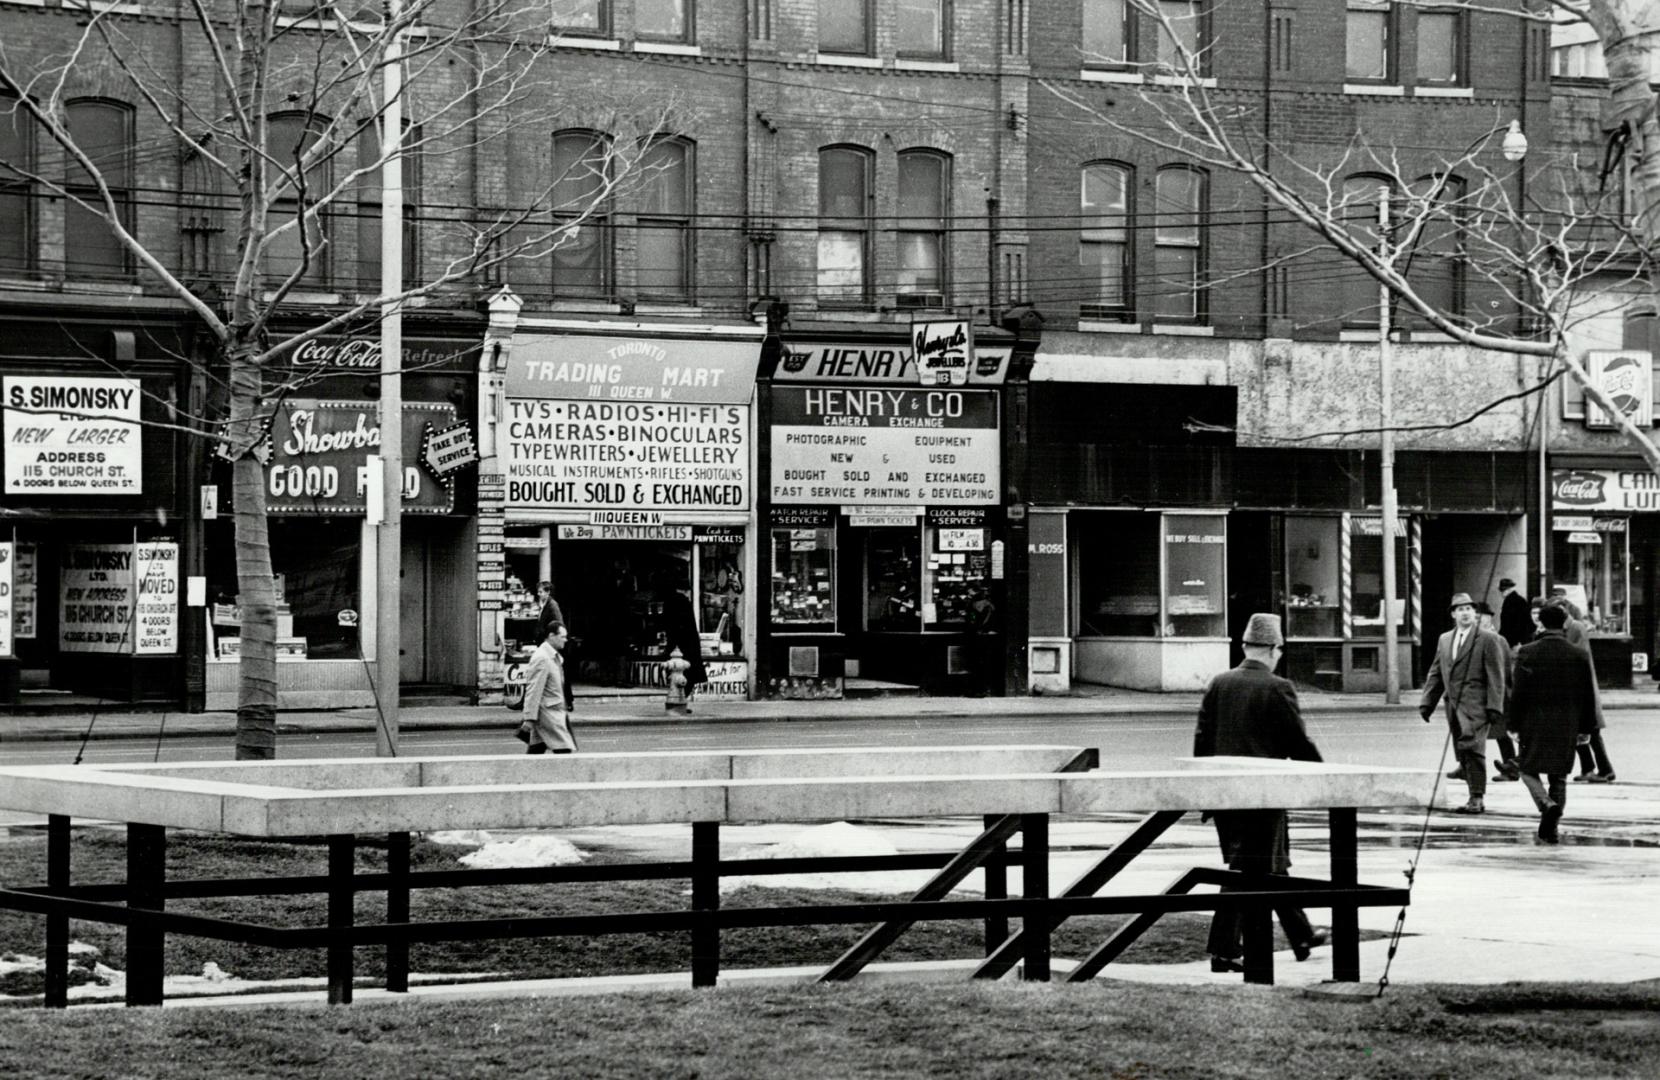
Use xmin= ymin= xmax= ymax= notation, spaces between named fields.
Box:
xmin=0 ymin=322 xmax=194 ymax=707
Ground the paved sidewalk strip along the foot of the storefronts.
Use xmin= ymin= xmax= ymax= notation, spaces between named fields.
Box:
xmin=0 ymin=687 xmax=1660 ymax=743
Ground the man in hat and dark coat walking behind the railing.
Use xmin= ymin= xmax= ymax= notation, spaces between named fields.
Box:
xmin=1194 ymin=614 xmax=1326 ymax=972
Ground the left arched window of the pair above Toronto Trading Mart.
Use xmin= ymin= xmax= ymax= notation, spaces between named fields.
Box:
xmin=553 ymin=131 xmax=611 ymax=297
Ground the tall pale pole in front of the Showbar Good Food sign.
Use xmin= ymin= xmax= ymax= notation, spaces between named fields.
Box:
xmin=375 ymin=0 xmax=403 ymax=758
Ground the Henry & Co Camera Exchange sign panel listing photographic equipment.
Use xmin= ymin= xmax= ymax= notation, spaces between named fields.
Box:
xmin=772 ymin=387 xmax=1003 ymax=506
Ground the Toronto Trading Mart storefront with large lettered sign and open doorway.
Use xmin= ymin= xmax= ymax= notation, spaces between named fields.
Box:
xmin=480 ymin=319 xmax=760 ymax=698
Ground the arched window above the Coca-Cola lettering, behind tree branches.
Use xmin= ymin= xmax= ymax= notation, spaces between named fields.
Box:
xmin=266 ymin=113 xmax=334 ymax=287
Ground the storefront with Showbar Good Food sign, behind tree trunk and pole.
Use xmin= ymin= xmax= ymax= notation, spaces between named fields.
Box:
xmin=204 ymin=337 xmax=478 ymax=708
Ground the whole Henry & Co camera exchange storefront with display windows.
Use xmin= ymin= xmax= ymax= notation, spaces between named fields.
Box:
xmin=764 ymin=324 xmax=1011 ymax=698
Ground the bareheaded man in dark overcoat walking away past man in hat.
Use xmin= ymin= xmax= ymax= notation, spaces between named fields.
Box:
xmin=1509 ymin=604 xmax=1597 ymax=844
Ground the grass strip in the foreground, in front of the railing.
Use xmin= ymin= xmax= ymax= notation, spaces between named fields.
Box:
xmin=0 ymin=982 xmax=1660 ymax=1080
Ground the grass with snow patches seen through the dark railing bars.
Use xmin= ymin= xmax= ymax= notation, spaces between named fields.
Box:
xmin=0 ymin=828 xmax=1374 ymax=995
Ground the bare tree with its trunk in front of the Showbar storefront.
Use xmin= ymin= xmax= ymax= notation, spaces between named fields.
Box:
xmin=0 ymin=0 xmax=674 ymax=758
